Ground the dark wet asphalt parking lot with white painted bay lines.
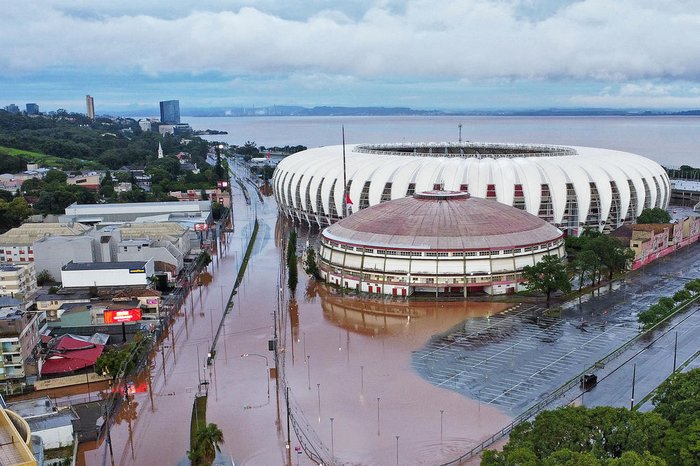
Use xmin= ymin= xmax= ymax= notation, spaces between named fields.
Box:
xmin=412 ymin=305 xmax=638 ymax=415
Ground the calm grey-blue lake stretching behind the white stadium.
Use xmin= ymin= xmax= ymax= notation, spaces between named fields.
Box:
xmin=182 ymin=116 xmax=700 ymax=167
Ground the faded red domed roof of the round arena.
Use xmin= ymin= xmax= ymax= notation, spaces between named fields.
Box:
xmin=323 ymin=191 xmax=562 ymax=250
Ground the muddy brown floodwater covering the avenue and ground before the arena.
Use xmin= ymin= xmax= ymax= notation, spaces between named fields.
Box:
xmin=78 ymin=165 xmax=510 ymax=466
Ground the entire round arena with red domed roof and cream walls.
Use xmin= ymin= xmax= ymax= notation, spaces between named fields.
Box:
xmin=319 ymin=191 xmax=565 ymax=297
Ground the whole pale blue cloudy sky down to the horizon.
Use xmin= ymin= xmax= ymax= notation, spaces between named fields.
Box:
xmin=0 ymin=0 xmax=700 ymax=114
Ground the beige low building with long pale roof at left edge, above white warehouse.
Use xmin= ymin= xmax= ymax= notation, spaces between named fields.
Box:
xmin=0 ymin=223 xmax=92 ymax=263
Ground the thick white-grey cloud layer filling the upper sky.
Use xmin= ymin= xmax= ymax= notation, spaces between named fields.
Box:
xmin=0 ymin=0 xmax=700 ymax=83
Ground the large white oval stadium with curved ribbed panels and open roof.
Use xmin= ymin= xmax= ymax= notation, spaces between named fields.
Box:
xmin=273 ymin=142 xmax=670 ymax=235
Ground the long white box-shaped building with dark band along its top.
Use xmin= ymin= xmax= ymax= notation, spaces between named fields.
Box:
xmin=61 ymin=259 xmax=155 ymax=288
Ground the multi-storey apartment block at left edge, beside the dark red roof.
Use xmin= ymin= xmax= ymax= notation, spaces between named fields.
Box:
xmin=0 ymin=308 xmax=41 ymax=383
